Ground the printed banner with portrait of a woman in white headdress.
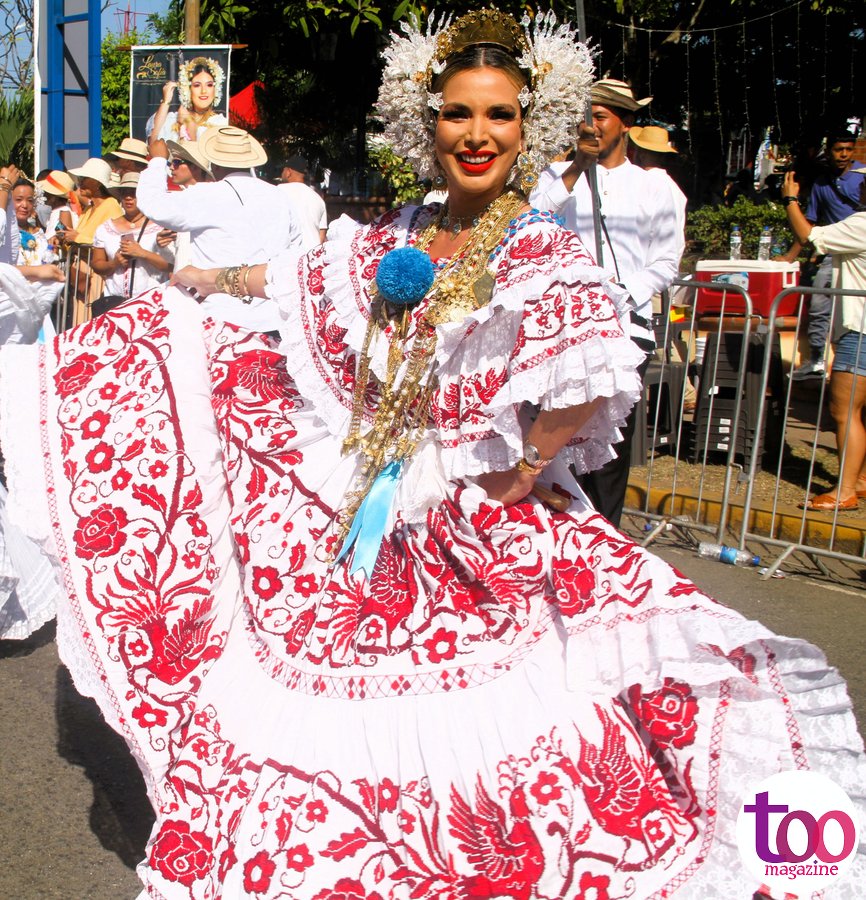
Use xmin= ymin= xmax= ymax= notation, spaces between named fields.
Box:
xmin=129 ymin=44 xmax=232 ymax=141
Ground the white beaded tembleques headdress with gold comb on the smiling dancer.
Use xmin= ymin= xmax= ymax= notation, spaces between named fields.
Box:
xmin=376 ymin=9 xmax=594 ymax=178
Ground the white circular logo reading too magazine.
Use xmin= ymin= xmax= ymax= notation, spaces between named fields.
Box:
xmin=737 ymin=771 xmax=858 ymax=897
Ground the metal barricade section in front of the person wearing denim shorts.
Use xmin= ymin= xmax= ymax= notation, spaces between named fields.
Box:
xmin=739 ymin=287 xmax=866 ymax=578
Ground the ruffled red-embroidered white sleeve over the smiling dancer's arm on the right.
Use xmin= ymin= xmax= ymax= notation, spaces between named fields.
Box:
xmin=434 ymin=213 xmax=643 ymax=478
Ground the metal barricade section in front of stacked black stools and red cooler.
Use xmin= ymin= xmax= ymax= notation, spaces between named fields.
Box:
xmin=625 ymin=278 xmax=769 ymax=546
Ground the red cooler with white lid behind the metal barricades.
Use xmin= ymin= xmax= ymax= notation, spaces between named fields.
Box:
xmin=695 ymin=259 xmax=801 ymax=316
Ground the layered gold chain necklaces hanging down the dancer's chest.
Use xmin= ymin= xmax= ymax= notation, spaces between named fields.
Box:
xmin=343 ymin=191 xmax=526 ymax=552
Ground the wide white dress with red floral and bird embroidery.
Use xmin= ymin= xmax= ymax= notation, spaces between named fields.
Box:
xmin=0 ymin=208 xmax=864 ymax=900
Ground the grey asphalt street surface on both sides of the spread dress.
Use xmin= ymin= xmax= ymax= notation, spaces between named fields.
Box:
xmin=0 ymin=540 xmax=866 ymax=900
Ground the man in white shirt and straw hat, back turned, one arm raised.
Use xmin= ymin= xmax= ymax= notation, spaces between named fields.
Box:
xmin=138 ymin=126 xmax=300 ymax=331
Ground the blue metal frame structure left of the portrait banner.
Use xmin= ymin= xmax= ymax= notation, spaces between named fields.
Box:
xmin=39 ymin=0 xmax=102 ymax=169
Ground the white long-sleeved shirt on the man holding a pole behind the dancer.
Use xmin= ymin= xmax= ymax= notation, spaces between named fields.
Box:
xmin=530 ymin=160 xmax=685 ymax=321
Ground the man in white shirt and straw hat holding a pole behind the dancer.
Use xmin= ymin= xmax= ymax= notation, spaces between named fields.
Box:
xmin=531 ymin=79 xmax=684 ymax=526
